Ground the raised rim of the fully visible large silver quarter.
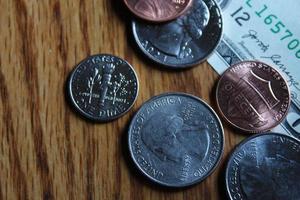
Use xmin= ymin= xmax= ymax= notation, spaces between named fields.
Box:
xmin=128 ymin=92 xmax=225 ymax=188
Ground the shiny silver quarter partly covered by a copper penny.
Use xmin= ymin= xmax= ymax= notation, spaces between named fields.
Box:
xmin=132 ymin=0 xmax=222 ymax=68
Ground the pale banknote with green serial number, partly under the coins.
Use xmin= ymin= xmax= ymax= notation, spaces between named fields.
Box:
xmin=208 ymin=0 xmax=300 ymax=139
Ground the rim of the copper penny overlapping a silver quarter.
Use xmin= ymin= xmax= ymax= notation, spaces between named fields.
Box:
xmin=123 ymin=0 xmax=194 ymax=23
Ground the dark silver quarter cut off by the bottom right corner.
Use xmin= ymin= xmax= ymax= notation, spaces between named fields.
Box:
xmin=226 ymin=133 xmax=300 ymax=200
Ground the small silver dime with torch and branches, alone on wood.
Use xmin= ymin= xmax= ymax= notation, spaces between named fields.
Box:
xmin=68 ymin=54 xmax=138 ymax=122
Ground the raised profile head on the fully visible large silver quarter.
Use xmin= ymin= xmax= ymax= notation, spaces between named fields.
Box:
xmin=142 ymin=113 xmax=209 ymax=166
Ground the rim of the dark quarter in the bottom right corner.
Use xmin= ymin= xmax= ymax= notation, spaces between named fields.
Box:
xmin=225 ymin=132 xmax=300 ymax=200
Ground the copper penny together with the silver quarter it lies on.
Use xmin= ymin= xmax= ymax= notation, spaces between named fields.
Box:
xmin=124 ymin=0 xmax=222 ymax=69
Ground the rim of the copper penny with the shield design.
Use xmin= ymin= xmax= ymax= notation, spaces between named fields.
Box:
xmin=216 ymin=60 xmax=291 ymax=134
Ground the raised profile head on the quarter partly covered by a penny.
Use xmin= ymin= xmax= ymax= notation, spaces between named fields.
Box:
xmin=148 ymin=0 xmax=209 ymax=58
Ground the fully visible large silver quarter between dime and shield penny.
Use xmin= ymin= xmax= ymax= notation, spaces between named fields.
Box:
xmin=128 ymin=93 xmax=224 ymax=187
